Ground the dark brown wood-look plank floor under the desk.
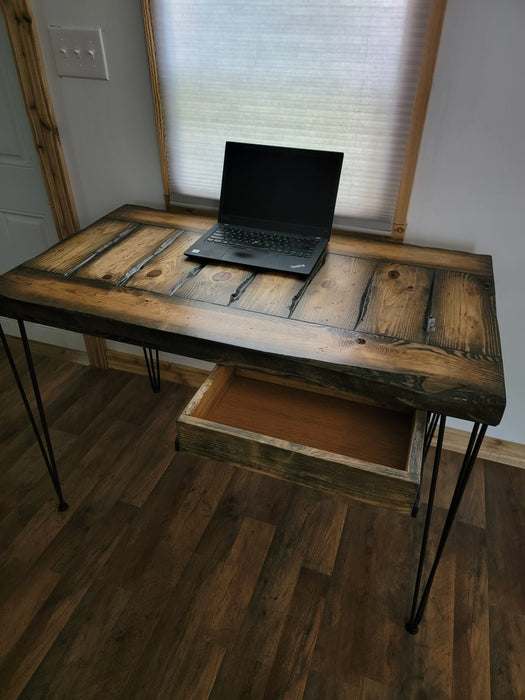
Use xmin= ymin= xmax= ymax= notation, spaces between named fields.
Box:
xmin=0 ymin=349 xmax=525 ymax=700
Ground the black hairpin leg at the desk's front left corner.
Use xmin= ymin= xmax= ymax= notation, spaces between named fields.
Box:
xmin=0 ymin=321 xmax=68 ymax=511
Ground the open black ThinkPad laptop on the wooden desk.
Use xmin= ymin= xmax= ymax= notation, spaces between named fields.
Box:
xmin=184 ymin=141 xmax=343 ymax=276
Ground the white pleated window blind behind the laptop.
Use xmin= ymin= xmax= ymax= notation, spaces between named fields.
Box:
xmin=152 ymin=0 xmax=429 ymax=231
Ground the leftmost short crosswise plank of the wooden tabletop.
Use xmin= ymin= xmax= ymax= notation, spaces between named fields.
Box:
xmin=25 ymin=218 xmax=136 ymax=275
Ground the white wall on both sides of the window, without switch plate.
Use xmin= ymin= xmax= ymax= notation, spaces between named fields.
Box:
xmin=27 ymin=0 xmax=525 ymax=443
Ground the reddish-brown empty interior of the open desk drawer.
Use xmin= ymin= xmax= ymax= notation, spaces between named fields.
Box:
xmin=192 ymin=368 xmax=414 ymax=471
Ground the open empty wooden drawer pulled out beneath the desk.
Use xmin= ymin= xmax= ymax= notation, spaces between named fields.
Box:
xmin=177 ymin=366 xmax=425 ymax=513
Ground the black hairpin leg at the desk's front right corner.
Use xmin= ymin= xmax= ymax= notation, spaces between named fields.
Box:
xmin=406 ymin=416 xmax=487 ymax=634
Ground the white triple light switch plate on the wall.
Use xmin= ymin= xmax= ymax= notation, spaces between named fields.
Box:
xmin=49 ymin=27 xmax=109 ymax=80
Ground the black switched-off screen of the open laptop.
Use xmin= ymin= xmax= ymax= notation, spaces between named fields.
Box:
xmin=219 ymin=141 xmax=343 ymax=235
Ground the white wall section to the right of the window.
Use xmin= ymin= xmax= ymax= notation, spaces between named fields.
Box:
xmin=407 ymin=0 xmax=525 ymax=443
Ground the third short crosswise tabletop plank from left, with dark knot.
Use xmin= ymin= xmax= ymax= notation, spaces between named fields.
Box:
xmin=126 ymin=231 xmax=201 ymax=295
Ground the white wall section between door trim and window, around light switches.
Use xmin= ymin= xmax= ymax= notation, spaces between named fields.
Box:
xmin=32 ymin=0 xmax=164 ymax=226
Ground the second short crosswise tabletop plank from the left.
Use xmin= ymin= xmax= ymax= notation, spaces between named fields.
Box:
xmin=75 ymin=226 xmax=180 ymax=285
